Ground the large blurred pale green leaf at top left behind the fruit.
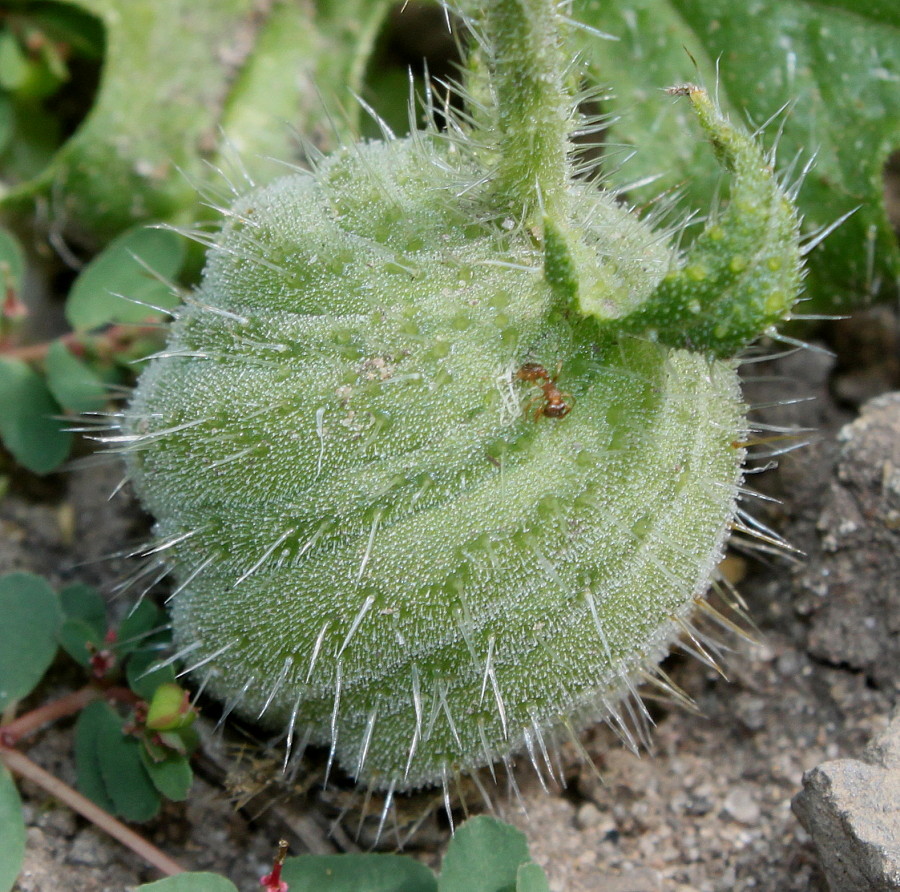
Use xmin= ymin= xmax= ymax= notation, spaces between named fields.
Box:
xmin=0 ymin=0 xmax=393 ymax=244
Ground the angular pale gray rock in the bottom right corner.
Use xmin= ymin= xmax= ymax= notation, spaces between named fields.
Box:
xmin=792 ymin=716 xmax=900 ymax=892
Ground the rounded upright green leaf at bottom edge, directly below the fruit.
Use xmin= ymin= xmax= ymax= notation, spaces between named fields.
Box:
xmin=438 ymin=815 xmax=531 ymax=892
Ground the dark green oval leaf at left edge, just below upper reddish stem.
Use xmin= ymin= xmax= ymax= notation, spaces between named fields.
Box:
xmin=0 ymin=359 xmax=72 ymax=474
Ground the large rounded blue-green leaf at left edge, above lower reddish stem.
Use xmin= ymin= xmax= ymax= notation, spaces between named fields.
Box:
xmin=0 ymin=573 xmax=62 ymax=712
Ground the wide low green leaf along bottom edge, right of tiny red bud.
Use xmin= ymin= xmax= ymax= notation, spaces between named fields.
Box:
xmin=281 ymin=854 xmax=438 ymax=892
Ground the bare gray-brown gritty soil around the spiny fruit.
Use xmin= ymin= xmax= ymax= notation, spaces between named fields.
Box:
xmin=0 ymin=308 xmax=900 ymax=892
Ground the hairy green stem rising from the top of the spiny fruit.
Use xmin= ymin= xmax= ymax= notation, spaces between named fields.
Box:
xmin=486 ymin=0 xmax=572 ymax=219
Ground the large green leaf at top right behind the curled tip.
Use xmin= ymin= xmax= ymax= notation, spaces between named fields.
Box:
xmin=573 ymin=0 xmax=900 ymax=306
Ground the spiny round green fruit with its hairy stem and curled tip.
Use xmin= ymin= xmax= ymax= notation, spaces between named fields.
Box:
xmin=117 ymin=0 xmax=799 ymax=791
